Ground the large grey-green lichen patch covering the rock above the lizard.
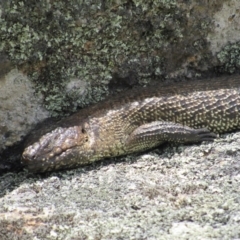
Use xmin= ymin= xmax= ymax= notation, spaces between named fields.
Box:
xmin=0 ymin=0 xmax=213 ymax=115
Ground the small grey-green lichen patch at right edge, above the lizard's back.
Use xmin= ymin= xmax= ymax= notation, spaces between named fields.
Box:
xmin=217 ymin=42 xmax=240 ymax=73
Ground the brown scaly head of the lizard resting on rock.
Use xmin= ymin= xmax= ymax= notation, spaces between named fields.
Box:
xmin=22 ymin=126 xmax=92 ymax=172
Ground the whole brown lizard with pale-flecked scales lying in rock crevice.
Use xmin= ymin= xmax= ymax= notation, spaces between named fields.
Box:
xmin=21 ymin=75 xmax=240 ymax=172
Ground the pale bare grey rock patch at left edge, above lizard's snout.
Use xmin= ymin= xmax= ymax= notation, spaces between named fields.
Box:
xmin=0 ymin=69 xmax=50 ymax=152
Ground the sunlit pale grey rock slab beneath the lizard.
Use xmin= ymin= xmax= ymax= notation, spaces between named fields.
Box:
xmin=0 ymin=133 xmax=240 ymax=240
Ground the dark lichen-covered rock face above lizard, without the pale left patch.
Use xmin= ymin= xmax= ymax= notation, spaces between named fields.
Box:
xmin=0 ymin=0 xmax=240 ymax=119
